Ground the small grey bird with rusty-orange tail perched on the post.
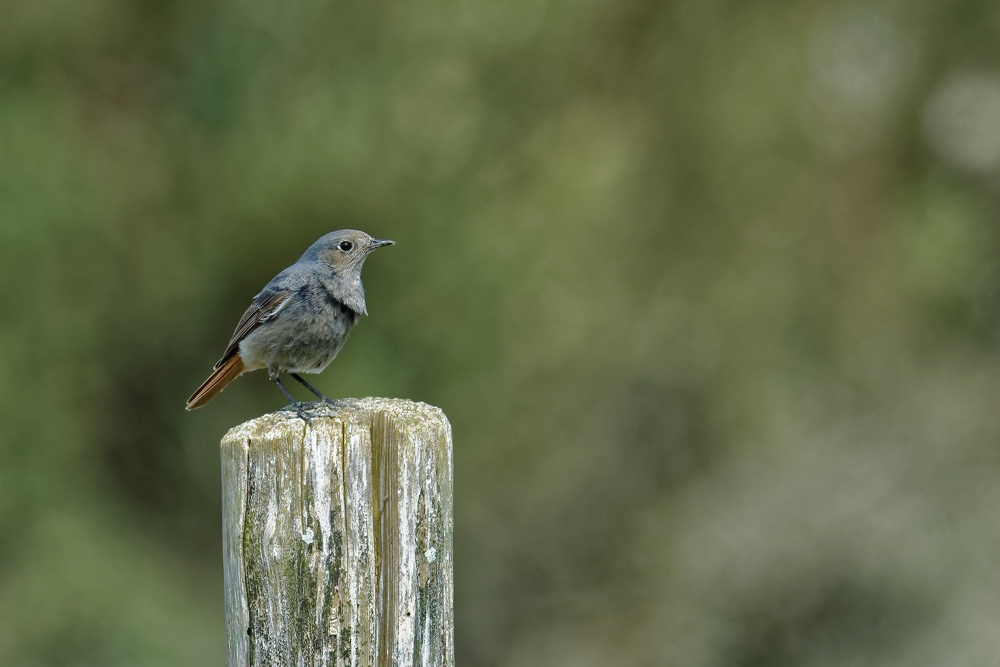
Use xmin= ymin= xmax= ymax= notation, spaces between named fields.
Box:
xmin=185 ymin=229 xmax=395 ymax=422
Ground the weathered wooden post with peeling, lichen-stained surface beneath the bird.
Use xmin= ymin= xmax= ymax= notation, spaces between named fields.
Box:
xmin=222 ymin=398 xmax=455 ymax=667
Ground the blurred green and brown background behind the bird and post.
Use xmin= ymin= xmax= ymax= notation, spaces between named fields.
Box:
xmin=0 ymin=0 xmax=1000 ymax=667
